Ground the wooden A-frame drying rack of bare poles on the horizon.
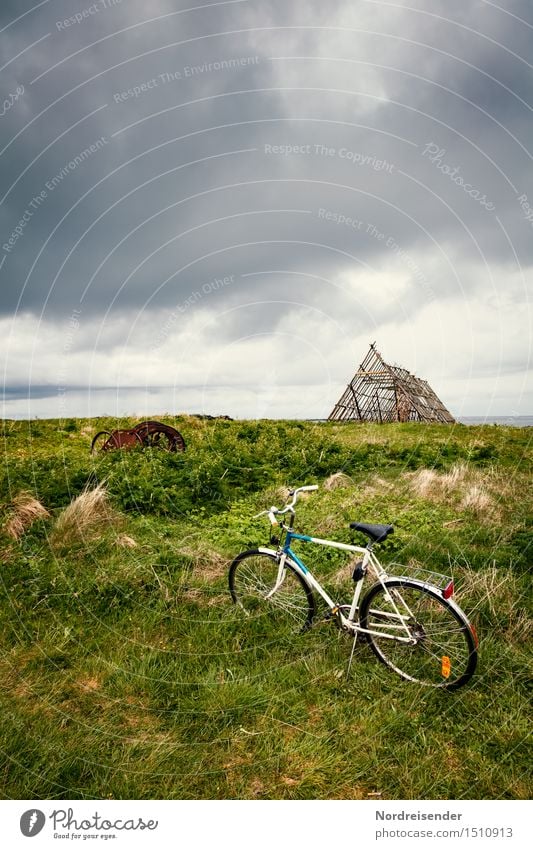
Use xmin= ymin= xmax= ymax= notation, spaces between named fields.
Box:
xmin=328 ymin=343 xmax=455 ymax=424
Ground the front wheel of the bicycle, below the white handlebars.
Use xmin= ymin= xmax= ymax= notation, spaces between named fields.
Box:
xmin=229 ymin=550 xmax=315 ymax=633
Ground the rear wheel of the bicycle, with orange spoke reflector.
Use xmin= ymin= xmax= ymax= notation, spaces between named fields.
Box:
xmin=360 ymin=578 xmax=477 ymax=690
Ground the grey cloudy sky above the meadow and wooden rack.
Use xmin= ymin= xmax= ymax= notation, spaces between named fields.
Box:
xmin=0 ymin=0 xmax=533 ymax=417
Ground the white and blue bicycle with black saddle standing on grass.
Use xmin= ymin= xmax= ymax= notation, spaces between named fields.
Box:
xmin=229 ymin=485 xmax=478 ymax=690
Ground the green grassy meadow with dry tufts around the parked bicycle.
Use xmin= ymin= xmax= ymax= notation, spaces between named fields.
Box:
xmin=0 ymin=417 xmax=533 ymax=799
